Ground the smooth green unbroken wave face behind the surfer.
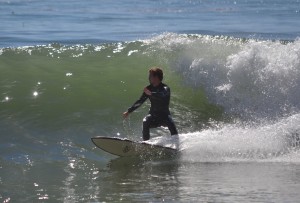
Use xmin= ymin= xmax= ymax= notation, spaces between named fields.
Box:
xmin=0 ymin=43 xmax=222 ymax=133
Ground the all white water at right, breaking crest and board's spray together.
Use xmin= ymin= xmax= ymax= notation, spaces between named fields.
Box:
xmin=139 ymin=33 xmax=300 ymax=163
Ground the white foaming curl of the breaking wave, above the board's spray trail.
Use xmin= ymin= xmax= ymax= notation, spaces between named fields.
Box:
xmin=147 ymin=33 xmax=300 ymax=118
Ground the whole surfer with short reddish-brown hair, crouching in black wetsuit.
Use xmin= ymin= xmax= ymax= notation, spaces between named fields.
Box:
xmin=123 ymin=67 xmax=178 ymax=140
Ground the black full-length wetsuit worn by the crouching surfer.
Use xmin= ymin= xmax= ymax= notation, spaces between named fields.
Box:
xmin=128 ymin=83 xmax=178 ymax=140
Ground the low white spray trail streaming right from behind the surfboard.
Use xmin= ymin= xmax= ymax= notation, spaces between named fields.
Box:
xmin=149 ymin=114 xmax=300 ymax=163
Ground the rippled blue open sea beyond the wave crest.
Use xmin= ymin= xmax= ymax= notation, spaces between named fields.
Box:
xmin=0 ymin=0 xmax=300 ymax=47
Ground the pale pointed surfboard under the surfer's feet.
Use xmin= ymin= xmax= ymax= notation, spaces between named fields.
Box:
xmin=91 ymin=136 xmax=178 ymax=157
